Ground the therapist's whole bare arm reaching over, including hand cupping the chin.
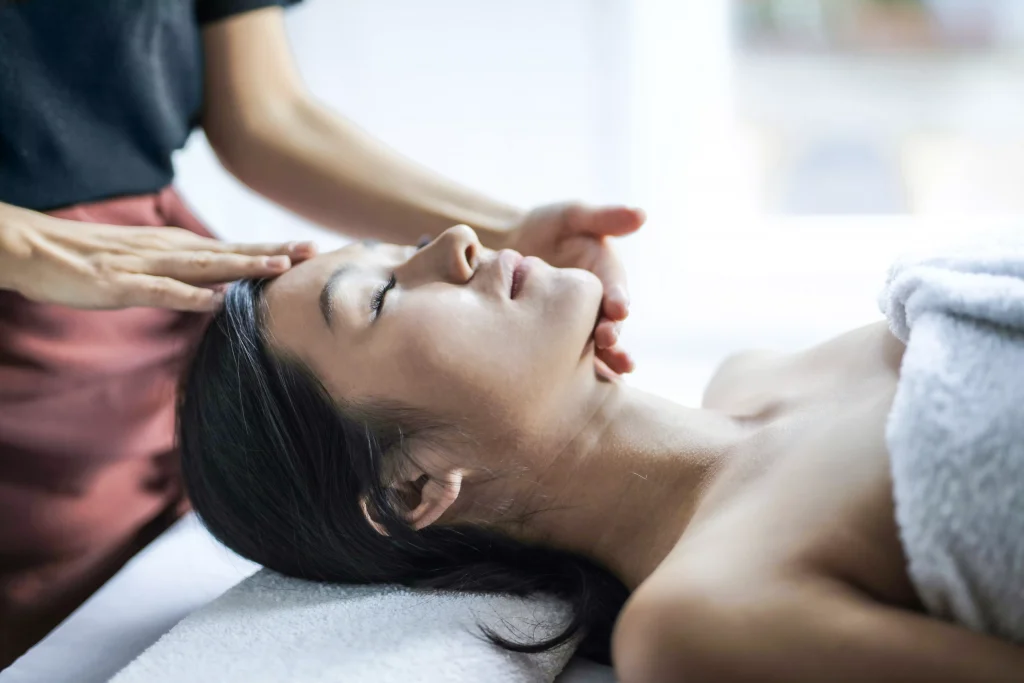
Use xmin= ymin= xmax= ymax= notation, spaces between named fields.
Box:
xmin=203 ymin=7 xmax=645 ymax=373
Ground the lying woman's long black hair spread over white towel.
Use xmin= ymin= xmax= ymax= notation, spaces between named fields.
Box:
xmin=178 ymin=281 xmax=628 ymax=663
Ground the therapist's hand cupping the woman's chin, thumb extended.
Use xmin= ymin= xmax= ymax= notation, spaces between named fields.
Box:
xmin=508 ymin=203 xmax=646 ymax=374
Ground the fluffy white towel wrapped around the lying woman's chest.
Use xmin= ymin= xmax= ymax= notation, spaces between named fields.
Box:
xmin=881 ymin=230 xmax=1024 ymax=643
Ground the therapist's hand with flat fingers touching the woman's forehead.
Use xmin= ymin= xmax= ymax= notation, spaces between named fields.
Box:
xmin=0 ymin=205 xmax=315 ymax=311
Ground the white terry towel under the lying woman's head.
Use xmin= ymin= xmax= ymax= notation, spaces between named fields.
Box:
xmin=112 ymin=569 xmax=573 ymax=683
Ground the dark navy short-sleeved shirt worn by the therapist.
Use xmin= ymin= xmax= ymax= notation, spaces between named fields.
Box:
xmin=0 ymin=0 xmax=299 ymax=210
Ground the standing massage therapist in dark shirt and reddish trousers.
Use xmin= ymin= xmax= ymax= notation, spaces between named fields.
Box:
xmin=0 ymin=0 xmax=643 ymax=668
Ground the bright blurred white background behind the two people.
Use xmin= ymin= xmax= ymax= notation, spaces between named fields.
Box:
xmin=177 ymin=0 xmax=1024 ymax=404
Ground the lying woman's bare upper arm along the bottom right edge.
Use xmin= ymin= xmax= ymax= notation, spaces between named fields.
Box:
xmin=612 ymin=544 xmax=1024 ymax=683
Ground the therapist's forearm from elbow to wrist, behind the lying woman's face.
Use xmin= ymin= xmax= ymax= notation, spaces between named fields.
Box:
xmin=204 ymin=97 xmax=523 ymax=247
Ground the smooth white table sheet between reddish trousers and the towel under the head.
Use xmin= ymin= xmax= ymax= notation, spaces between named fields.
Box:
xmin=0 ymin=515 xmax=615 ymax=683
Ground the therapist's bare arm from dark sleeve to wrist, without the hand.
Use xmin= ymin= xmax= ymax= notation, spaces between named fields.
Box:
xmin=203 ymin=7 xmax=525 ymax=247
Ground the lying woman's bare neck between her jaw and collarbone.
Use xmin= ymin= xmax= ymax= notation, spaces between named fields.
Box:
xmin=487 ymin=383 xmax=750 ymax=590
